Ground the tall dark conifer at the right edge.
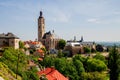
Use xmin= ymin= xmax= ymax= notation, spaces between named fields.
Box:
xmin=108 ymin=46 xmax=120 ymax=80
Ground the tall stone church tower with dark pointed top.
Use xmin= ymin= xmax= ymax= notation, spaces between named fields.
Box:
xmin=38 ymin=11 xmax=45 ymax=41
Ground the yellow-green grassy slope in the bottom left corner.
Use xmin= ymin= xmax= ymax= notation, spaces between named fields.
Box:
xmin=0 ymin=62 xmax=22 ymax=80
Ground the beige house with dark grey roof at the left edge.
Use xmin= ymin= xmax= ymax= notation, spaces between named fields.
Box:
xmin=0 ymin=33 xmax=20 ymax=49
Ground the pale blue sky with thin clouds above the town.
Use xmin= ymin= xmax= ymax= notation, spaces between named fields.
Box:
xmin=0 ymin=0 xmax=120 ymax=41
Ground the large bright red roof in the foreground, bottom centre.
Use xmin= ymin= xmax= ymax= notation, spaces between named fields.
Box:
xmin=38 ymin=68 xmax=68 ymax=80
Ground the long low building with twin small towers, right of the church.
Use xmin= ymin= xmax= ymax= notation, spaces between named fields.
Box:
xmin=64 ymin=37 xmax=96 ymax=56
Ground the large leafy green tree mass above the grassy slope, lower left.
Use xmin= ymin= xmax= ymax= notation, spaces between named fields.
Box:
xmin=0 ymin=48 xmax=37 ymax=80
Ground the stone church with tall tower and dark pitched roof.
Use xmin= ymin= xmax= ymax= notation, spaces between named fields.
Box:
xmin=38 ymin=11 xmax=60 ymax=50
